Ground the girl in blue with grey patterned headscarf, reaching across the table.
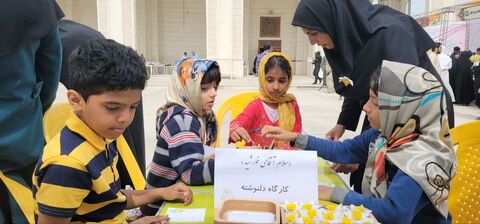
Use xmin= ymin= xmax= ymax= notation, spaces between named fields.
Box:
xmin=262 ymin=61 xmax=457 ymax=223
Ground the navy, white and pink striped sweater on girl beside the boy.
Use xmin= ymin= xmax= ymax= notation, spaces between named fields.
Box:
xmin=142 ymin=106 xmax=214 ymax=215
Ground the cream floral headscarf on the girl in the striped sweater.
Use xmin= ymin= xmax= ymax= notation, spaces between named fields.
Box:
xmin=157 ymin=59 xmax=217 ymax=146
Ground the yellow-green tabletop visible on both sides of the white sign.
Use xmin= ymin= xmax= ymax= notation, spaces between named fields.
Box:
xmin=159 ymin=158 xmax=348 ymax=223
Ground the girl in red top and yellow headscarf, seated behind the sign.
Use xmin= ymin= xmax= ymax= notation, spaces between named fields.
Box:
xmin=229 ymin=52 xmax=302 ymax=149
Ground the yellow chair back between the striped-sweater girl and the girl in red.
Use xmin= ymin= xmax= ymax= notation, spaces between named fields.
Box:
xmin=215 ymin=91 xmax=260 ymax=147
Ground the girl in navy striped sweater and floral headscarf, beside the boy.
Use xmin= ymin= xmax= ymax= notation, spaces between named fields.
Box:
xmin=142 ymin=59 xmax=221 ymax=215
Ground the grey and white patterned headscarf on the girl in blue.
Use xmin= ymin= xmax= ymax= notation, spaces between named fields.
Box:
xmin=363 ymin=61 xmax=457 ymax=217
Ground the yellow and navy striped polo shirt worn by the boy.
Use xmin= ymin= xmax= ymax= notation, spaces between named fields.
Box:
xmin=33 ymin=113 xmax=126 ymax=223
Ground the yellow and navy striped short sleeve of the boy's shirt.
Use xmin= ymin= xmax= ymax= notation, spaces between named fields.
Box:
xmin=35 ymin=155 xmax=92 ymax=218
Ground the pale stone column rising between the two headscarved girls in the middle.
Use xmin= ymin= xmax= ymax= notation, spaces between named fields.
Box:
xmin=206 ymin=0 xmax=244 ymax=78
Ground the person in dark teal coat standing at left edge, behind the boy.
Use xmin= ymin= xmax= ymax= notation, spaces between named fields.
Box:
xmin=0 ymin=0 xmax=64 ymax=223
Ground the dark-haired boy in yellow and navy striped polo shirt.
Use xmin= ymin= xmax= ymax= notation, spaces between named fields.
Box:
xmin=33 ymin=39 xmax=192 ymax=223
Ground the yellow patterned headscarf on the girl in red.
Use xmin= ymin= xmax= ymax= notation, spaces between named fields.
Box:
xmin=258 ymin=52 xmax=295 ymax=145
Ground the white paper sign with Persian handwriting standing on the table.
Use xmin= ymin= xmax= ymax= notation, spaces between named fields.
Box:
xmin=214 ymin=149 xmax=318 ymax=208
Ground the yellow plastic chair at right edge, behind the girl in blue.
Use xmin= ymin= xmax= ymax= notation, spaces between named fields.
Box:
xmin=448 ymin=121 xmax=480 ymax=223
